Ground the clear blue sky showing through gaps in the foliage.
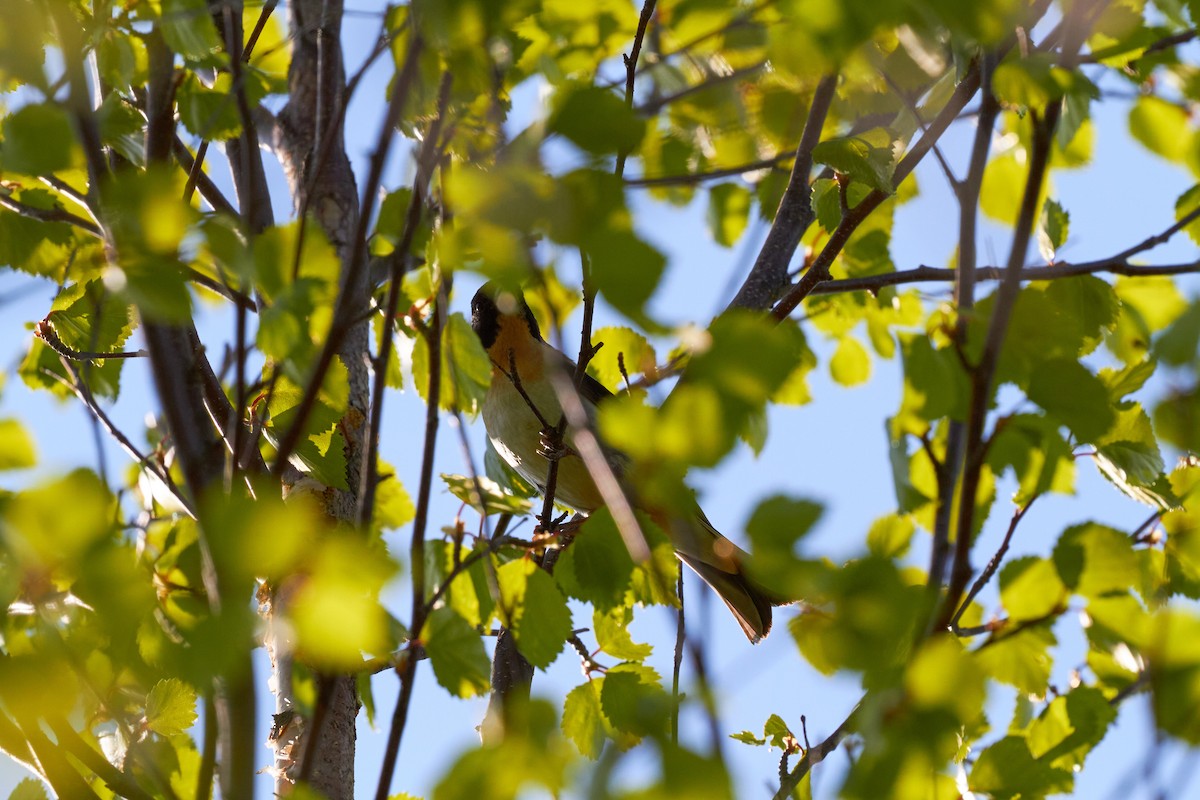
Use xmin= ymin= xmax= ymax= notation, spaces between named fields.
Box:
xmin=0 ymin=6 xmax=1200 ymax=800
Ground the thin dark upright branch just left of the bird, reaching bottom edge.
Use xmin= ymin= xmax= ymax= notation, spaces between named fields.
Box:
xmin=376 ymin=284 xmax=445 ymax=800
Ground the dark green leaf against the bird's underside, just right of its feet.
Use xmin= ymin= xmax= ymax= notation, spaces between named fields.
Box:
xmin=554 ymin=507 xmax=634 ymax=613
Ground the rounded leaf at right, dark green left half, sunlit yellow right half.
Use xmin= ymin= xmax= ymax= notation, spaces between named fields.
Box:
xmin=1054 ymin=523 xmax=1138 ymax=597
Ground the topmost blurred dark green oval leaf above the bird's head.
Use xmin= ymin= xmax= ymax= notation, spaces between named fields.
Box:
xmin=547 ymin=86 xmax=646 ymax=155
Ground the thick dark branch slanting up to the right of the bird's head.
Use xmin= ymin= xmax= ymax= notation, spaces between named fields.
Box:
xmin=730 ymin=74 xmax=838 ymax=308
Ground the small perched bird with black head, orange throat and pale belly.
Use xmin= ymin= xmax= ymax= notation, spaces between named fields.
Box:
xmin=470 ymin=282 xmax=787 ymax=643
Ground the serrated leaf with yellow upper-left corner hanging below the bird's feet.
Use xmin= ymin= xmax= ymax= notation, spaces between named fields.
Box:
xmin=496 ymin=559 xmax=571 ymax=669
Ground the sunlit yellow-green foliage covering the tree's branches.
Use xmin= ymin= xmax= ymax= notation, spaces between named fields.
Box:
xmin=0 ymin=0 xmax=1200 ymax=798
